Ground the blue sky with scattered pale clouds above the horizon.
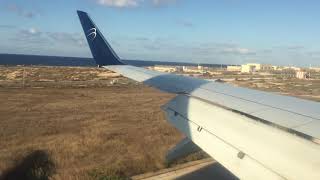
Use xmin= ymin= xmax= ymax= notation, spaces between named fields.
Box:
xmin=0 ymin=0 xmax=320 ymax=67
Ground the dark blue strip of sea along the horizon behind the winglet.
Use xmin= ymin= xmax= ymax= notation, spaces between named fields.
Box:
xmin=0 ymin=54 xmax=226 ymax=67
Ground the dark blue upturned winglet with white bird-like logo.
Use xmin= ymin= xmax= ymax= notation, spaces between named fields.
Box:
xmin=77 ymin=11 xmax=124 ymax=66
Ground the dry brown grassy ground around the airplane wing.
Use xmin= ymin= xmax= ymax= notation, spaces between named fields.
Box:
xmin=0 ymin=67 xmax=320 ymax=179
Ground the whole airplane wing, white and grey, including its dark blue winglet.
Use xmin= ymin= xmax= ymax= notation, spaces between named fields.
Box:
xmin=78 ymin=11 xmax=320 ymax=179
